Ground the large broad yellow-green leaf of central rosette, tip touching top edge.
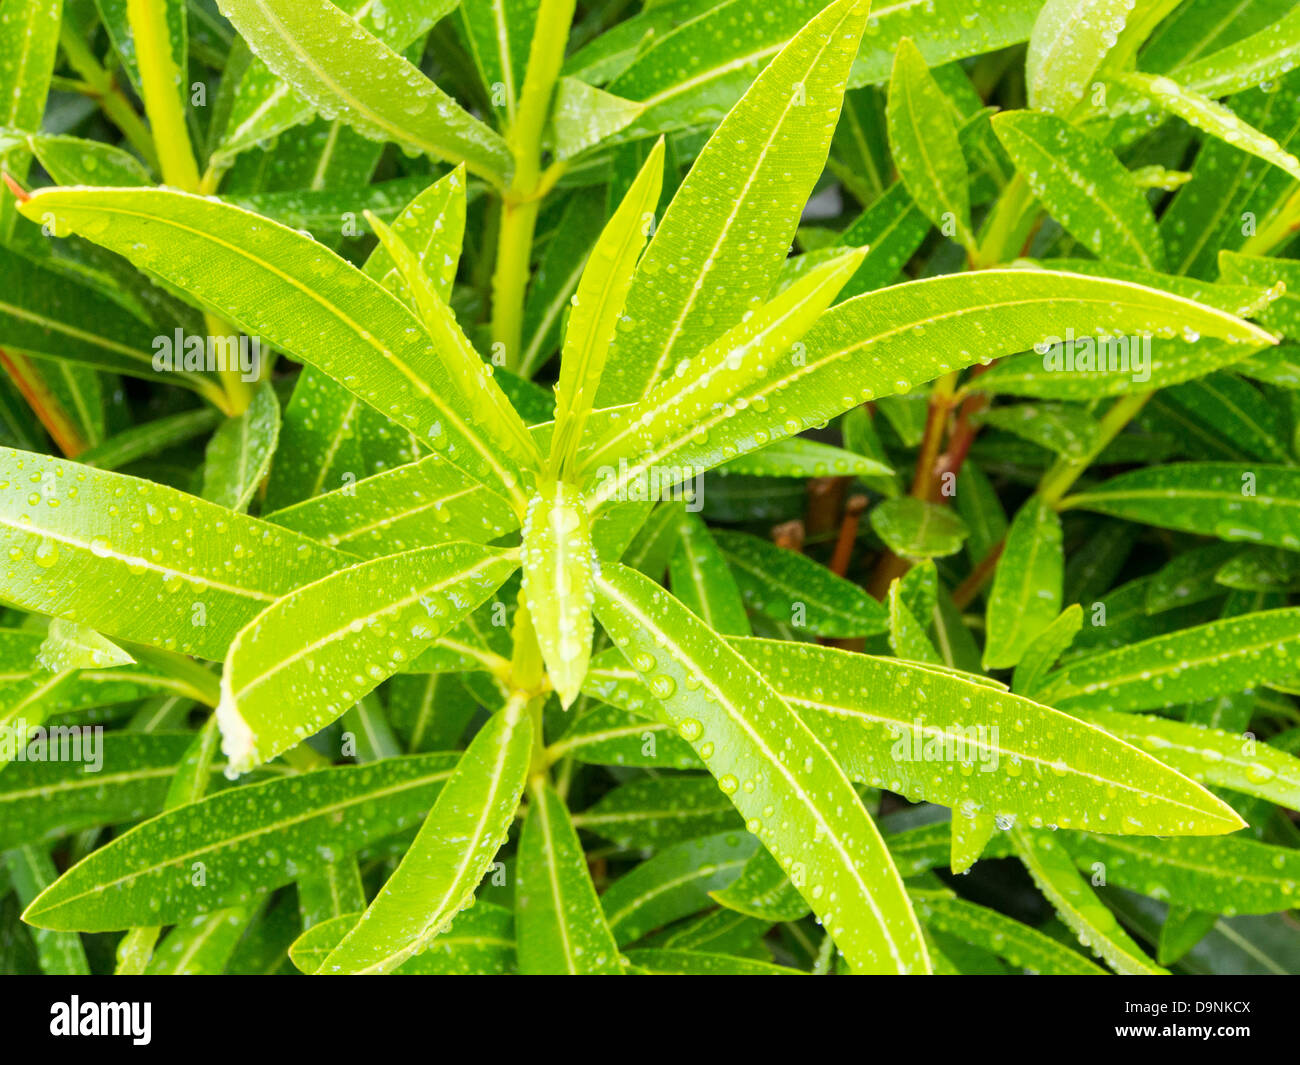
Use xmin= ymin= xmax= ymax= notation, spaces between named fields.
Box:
xmin=599 ymin=0 xmax=867 ymax=406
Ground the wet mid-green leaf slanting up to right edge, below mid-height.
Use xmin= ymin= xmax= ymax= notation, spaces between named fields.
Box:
xmin=1039 ymin=607 xmax=1300 ymax=710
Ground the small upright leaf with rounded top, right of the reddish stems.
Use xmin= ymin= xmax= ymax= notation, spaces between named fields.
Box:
xmin=984 ymin=495 xmax=1065 ymax=670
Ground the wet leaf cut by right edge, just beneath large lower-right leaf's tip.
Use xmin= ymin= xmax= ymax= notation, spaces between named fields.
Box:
xmin=1062 ymin=832 xmax=1300 ymax=917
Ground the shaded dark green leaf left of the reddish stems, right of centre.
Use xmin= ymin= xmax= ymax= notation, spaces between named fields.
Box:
xmin=712 ymin=529 xmax=885 ymax=637
